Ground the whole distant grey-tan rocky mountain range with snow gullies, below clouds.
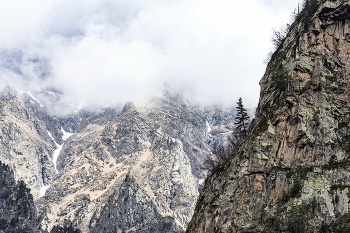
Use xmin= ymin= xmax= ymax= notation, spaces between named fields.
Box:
xmin=0 ymin=87 xmax=238 ymax=233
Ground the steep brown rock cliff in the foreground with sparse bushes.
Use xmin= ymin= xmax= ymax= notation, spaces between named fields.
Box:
xmin=187 ymin=0 xmax=350 ymax=233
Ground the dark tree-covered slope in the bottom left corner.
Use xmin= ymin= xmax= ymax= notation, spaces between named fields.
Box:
xmin=0 ymin=162 xmax=37 ymax=233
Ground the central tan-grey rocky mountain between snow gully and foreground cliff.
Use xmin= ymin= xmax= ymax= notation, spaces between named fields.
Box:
xmin=37 ymin=94 xmax=210 ymax=233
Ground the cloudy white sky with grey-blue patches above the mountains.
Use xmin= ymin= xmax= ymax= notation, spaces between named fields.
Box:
xmin=0 ymin=0 xmax=298 ymax=113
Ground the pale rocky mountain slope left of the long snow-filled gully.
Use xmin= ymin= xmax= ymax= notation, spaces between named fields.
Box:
xmin=0 ymin=87 xmax=56 ymax=199
